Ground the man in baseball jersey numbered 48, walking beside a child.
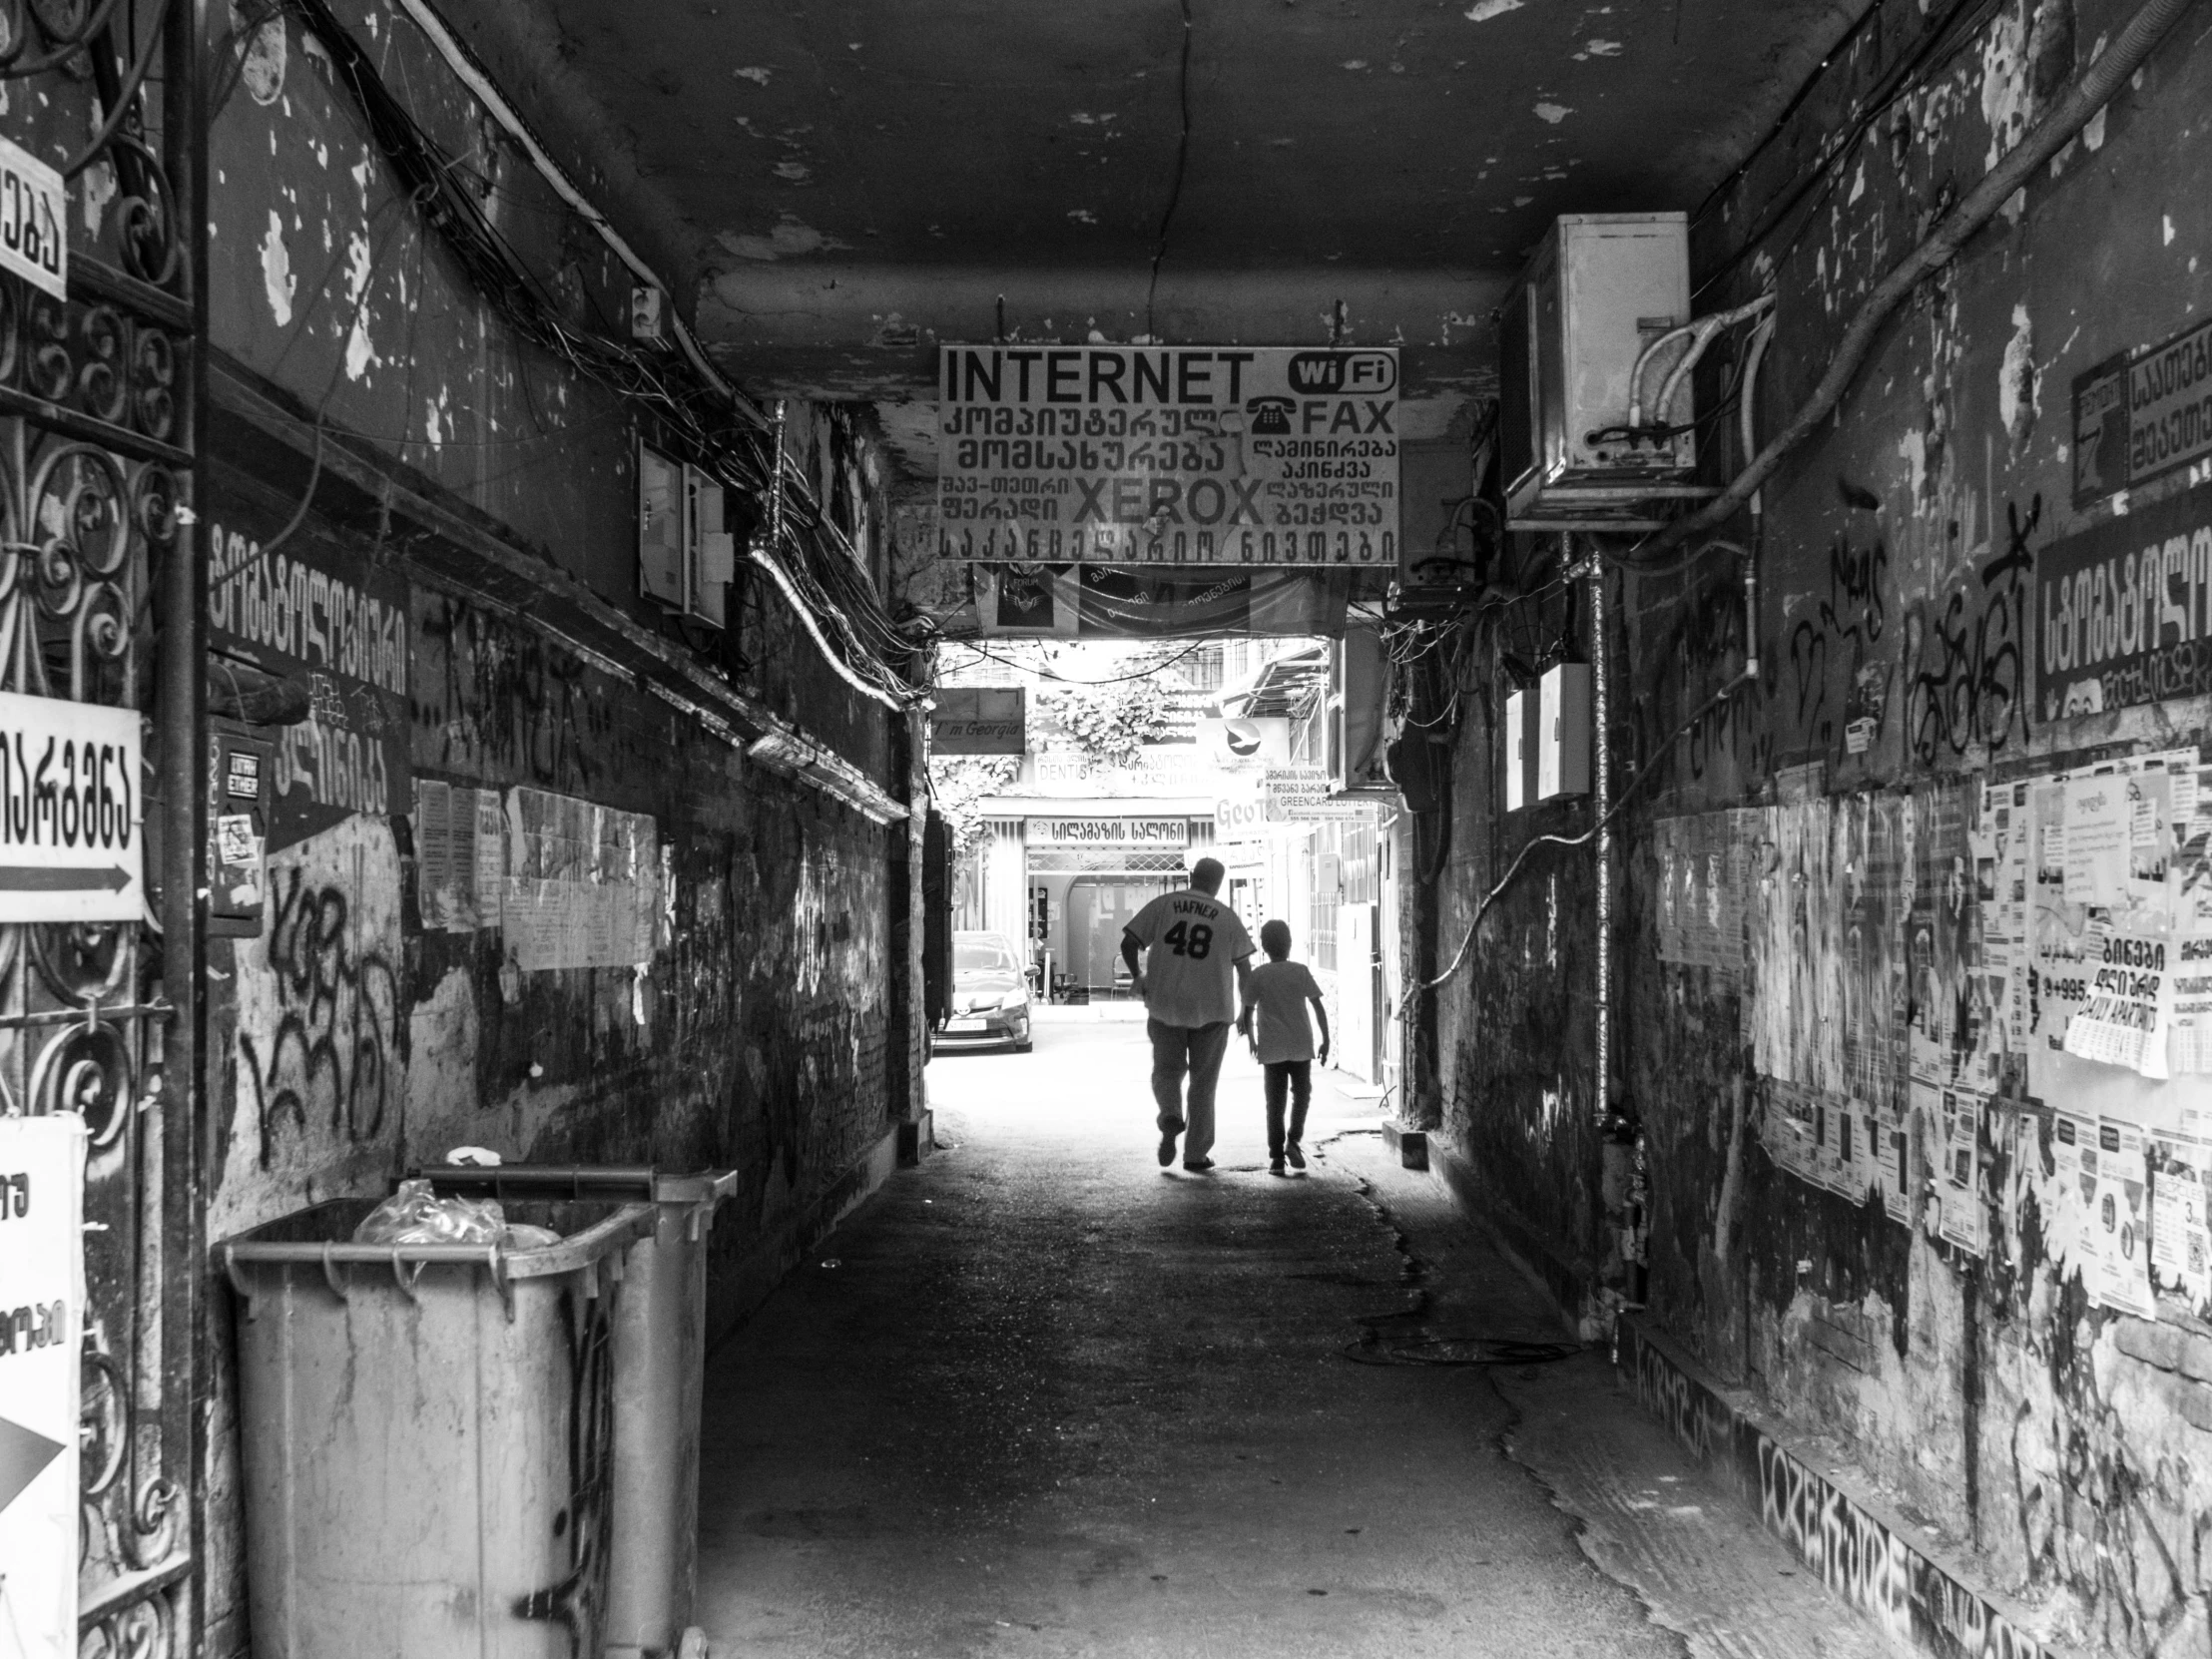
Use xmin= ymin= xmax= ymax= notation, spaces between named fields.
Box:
xmin=1122 ymin=858 xmax=1252 ymax=1170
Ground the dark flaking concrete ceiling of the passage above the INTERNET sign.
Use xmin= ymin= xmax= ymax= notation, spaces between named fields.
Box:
xmin=517 ymin=0 xmax=1863 ymax=471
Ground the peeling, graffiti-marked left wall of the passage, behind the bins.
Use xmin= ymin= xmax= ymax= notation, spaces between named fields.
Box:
xmin=204 ymin=0 xmax=920 ymax=1655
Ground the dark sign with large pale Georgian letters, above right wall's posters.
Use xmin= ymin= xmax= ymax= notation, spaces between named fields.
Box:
xmin=2035 ymin=484 xmax=2212 ymax=719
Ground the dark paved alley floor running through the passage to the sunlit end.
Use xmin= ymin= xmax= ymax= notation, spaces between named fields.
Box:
xmin=699 ymin=1011 xmax=1885 ymax=1659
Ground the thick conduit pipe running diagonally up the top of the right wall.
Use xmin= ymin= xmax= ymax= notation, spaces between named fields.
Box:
xmin=1637 ymin=0 xmax=2196 ymax=557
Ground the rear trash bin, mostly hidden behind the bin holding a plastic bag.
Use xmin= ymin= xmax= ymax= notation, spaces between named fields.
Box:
xmin=409 ymin=1164 xmax=737 ymax=1659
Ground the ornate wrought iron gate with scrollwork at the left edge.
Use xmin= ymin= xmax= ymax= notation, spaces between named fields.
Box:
xmin=0 ymin=0 xmax=204 ymax=1659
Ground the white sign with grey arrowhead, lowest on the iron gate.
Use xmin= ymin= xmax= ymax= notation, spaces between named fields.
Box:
xmin=0 ymin=1115 xmax=84 ymax=1659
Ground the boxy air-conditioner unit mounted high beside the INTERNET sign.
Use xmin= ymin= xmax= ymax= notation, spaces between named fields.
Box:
xmin=1497 ymin=213 xmax=1697 ymax=529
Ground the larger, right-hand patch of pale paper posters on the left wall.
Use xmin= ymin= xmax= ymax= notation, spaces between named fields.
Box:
xmin=500 ymin=790 xmax=659 ymax=971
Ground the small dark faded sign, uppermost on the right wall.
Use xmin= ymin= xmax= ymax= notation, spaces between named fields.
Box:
xmin=2075 ymin=320 xmax=2212 ymax=506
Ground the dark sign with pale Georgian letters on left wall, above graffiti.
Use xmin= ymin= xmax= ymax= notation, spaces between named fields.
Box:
xmin=208 ymin=478 xmax=413 ymax=851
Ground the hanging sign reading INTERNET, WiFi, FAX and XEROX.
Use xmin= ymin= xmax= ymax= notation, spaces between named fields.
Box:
xmin=938 ymin=345 xmax=1398 ymax=569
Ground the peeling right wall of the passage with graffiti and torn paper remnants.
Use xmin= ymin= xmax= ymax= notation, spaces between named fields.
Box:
xmin=1440 ymin=0 xmax=2212 ymax=1655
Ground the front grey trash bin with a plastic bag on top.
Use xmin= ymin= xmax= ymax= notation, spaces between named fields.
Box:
xmin=217 ymin=1199 xmax=657 ymax=1659
